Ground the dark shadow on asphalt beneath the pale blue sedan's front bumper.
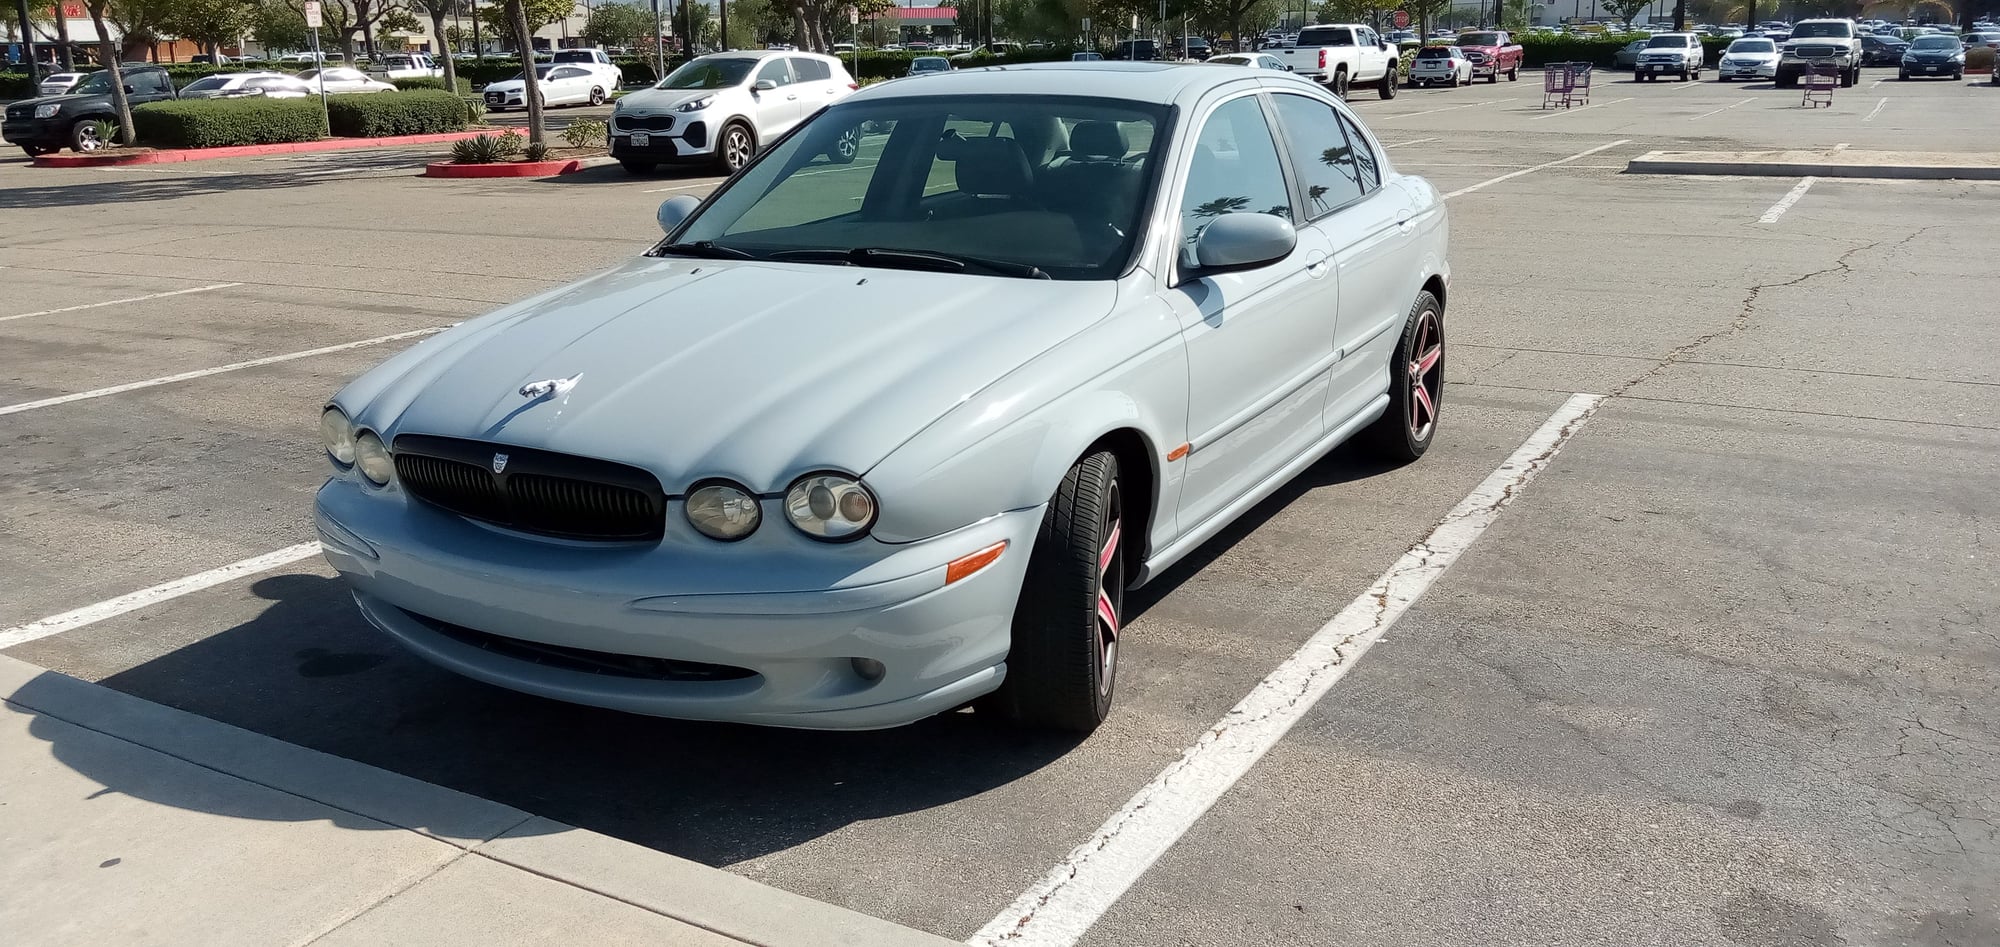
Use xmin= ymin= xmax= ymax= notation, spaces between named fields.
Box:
xmin=82 ymin=573 xmax=1078 ymax=865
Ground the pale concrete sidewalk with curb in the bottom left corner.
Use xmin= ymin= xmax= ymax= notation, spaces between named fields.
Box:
xmin=0 ymin=655 xmax=954 ymax=947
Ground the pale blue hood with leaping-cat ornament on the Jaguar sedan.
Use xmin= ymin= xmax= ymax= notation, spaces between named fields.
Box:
xmin=348 ymin=258 xmax=1116 ymax=491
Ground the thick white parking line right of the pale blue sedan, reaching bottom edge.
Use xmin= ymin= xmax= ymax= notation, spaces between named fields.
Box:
xmin=966 ymin=394 xmax=1604 ymax=947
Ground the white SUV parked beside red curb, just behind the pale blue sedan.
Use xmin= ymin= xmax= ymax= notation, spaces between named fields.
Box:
xmin=612 ymin=50 xmax=860 ymax=174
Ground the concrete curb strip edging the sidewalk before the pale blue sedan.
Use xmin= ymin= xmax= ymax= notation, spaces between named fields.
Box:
xmin=0 ymin=655 xmax=956 ymax=947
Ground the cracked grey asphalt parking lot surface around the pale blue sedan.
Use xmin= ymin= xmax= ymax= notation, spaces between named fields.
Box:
xmin=0 ymin=70 xmax=2000 ymax=947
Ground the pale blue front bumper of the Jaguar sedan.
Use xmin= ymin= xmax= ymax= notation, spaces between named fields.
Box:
xmin=316 ymin=477 xmax=1042 ymax=729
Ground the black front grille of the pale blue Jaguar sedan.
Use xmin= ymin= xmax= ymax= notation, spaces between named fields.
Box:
xmin=394 ymin=434 xmax=666 ymax=541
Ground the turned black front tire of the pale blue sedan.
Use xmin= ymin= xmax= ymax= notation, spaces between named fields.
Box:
xmin=982 ymin=452 xmax=1130 ymax=733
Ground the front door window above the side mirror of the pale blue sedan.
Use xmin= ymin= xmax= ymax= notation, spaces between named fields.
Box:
xmin=1180 ymin=96 xmax=1296 ymax=264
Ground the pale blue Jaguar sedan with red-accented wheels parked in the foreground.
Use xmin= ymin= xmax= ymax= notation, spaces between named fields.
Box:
xmin=318 ymin=62 xmax=1450 ymax=731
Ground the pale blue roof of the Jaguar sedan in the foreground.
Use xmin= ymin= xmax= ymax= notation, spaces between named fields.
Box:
xmin=848 ymin=60 xmax=1272 ymax=106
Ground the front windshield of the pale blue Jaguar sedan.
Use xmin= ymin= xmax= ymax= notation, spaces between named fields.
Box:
xmin=668 ymin=96 xmax=1168 ymax=280
